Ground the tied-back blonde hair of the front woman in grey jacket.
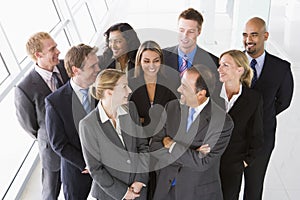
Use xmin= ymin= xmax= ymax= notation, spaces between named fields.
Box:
xmin=91 ymin=69 xmax=126 ymax=100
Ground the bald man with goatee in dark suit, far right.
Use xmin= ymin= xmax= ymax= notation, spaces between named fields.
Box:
xmin=243 ymin=17 xmax=294 ymax=200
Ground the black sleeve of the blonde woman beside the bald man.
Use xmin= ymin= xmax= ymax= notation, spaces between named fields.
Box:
xmin=244 ymin=96 xmax=264 ymax=166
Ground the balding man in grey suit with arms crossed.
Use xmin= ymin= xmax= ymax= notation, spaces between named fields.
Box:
xmin=150 ymin=65 xmax=233 ymax=200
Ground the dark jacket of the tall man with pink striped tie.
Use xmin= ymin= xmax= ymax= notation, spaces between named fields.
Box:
xmin=163 ymin=45 xmax=222 ymax=104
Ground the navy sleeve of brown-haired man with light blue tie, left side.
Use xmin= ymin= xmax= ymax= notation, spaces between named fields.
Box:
xmin=45 ymin=98 xmax=86 ymax=171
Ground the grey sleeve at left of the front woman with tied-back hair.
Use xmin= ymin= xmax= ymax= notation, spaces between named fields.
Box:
xmin=79 ymin=120 xmax=128 ymax=199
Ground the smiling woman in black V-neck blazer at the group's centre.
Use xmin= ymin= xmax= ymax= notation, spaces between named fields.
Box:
xmin=129 ymin=40 xmax=176 ymax=199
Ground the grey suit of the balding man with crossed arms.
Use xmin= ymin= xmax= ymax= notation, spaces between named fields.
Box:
xmin=150 ymin=100 xmax=233 ymax=200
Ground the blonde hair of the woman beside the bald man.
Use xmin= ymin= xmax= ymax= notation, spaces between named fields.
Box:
xmin=220 ymin=50 xmax=253 ymax=87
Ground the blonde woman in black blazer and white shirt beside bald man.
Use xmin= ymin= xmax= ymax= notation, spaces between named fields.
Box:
xmin=218 ymin=50 xmax=263 ymax=200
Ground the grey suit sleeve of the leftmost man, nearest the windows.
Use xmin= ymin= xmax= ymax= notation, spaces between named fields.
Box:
xmin=14 ymin=86 xmax=39 ymax=139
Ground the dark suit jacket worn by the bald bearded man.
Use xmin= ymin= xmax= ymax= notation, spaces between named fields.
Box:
xmin=253 ymin=52 xmax=294 ymax=150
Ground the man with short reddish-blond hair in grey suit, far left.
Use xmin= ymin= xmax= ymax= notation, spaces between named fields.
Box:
xmin=15 ymin=32 xmax=68 ymax=200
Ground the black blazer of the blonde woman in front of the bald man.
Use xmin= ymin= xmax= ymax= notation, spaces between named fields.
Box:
xmin=221 ymin=86 xmax=264 ymax=170
